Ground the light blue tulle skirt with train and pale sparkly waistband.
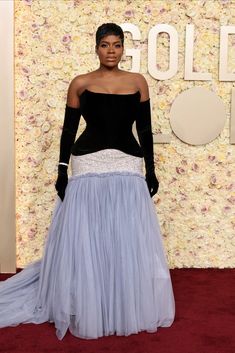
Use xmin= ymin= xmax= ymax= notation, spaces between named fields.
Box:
xmin=0 ymin=149 xmax=175 ymax=339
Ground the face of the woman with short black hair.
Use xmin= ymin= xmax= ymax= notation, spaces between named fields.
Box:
xmin=96 ymin=35 xmax=124 ymax=67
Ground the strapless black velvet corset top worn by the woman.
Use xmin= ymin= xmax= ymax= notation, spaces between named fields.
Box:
xmin=71 ymin=89 xmax=143 ymax=157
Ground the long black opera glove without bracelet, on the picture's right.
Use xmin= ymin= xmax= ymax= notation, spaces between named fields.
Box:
xmin=136 ymin=99 xmax=159 ymax=197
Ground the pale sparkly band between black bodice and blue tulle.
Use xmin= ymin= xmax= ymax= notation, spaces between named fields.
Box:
xmin=71 ymin=148 xmax=143 ymax=176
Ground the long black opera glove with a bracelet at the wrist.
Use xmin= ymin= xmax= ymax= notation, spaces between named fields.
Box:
xmin=55 ymin=104 xmax=81 ymax=201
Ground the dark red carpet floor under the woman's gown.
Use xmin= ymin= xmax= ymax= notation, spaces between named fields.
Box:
xmin=0 ymin=269 xmax=235 ymax=353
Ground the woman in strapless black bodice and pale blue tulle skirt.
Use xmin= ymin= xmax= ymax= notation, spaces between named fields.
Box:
xmin=0 ymin=23 xmax=175 ymax=339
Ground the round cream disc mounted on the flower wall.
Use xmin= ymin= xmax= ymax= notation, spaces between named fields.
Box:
xmin=170 ymin=87 xmax=226 ymax=145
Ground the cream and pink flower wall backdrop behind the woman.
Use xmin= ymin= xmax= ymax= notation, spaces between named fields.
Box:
xmin=15 ymin=0 xmax=235 ymax=268
